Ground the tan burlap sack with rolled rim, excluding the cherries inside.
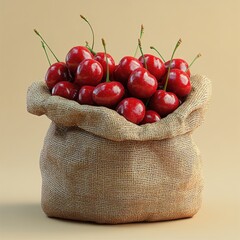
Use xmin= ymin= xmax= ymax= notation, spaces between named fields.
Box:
xmin=27 ymin=75 xmax=211 ymax=224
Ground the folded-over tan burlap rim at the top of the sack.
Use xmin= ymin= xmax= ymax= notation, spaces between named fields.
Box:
xmin=27 ymin=75 xmax=211 ymax=141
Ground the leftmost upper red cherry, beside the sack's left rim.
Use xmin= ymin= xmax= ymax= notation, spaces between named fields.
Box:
xmin=45 ymin=62 xmax=70 ymax=90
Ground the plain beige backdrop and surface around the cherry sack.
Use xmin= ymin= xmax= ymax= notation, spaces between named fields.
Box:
xmin=0 ymin=0 xmax=240 ymax=240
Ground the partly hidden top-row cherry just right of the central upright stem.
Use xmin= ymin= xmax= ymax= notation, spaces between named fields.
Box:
xmin=114 ymin=56 xmax=142 ymax=85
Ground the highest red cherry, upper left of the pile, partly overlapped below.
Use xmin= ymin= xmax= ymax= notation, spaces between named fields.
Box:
xmin=65 ymin=46 xmax=93 ymax=76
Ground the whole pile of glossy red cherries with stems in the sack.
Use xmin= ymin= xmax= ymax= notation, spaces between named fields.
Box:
xmin=34 ymin=15 xmax=200 ymax=125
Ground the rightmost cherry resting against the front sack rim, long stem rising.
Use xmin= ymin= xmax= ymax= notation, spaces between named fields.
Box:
xmin=149 ymin=90 xmax=180 ymax=118
